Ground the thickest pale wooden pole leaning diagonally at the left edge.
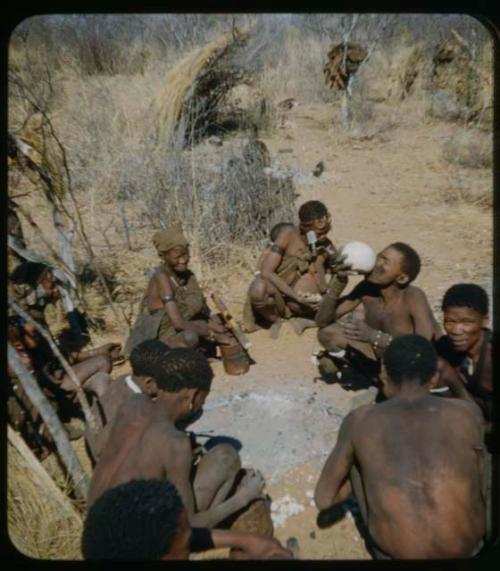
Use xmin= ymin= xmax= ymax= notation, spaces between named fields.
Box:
xmin=7 ymin=343 xmax=89 ymax=499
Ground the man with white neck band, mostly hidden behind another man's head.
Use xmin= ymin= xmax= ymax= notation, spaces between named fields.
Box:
xmin=85 ymin=339 xmax=170 ymax=463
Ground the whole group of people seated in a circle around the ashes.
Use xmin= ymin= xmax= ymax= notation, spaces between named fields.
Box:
xmin=8 ymin=201 xmax=494 ymax=559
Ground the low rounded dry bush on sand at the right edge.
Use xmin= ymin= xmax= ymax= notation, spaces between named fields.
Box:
xmin=443 ymin=129 xmax=493 ymax=169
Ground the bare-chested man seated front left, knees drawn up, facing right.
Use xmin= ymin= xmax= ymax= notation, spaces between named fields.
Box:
xmin=88 ymin=348 xmax=264 ymax=527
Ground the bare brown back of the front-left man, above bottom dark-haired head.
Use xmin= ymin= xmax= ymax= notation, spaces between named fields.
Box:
xmin=88 ymin=395 xmax=189 ymax=507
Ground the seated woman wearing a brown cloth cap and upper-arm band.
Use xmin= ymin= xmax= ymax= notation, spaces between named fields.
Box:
xmin=125 ymin=222 xmax=234 ymax=354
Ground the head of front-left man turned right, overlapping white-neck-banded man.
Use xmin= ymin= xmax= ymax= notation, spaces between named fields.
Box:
xmin=150 ymin=348 xmax=214 ymax=420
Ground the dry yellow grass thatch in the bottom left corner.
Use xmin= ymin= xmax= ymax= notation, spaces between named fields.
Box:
xmin=7 ymin=431 xmax=82 ymax=560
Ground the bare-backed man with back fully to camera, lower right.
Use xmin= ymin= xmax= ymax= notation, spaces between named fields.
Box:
xmin=314 ymin=335 xmax=486 ymax=559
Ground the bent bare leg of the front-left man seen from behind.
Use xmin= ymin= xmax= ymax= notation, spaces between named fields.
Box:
xmin=193 ymin=444 xmax=241 ymax=511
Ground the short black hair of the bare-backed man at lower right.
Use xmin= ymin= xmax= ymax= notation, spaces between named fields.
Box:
xmin=382 ymin=335 xmax=437 ymax=385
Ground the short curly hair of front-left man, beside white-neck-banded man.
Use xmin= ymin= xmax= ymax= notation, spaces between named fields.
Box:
xmin=154 ymin=347 xmax=214 ymax=392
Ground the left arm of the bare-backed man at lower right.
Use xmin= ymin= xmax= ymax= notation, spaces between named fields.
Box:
xmin=314 ymin=405 xmax=358 ymax=510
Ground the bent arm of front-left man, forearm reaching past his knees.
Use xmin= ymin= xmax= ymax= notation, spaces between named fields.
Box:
xmin=164 ymin=435 xmax=263 ymax=528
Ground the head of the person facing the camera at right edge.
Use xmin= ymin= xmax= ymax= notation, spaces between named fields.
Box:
xmin=441 ymin=284 xmax=488 ymax=352
